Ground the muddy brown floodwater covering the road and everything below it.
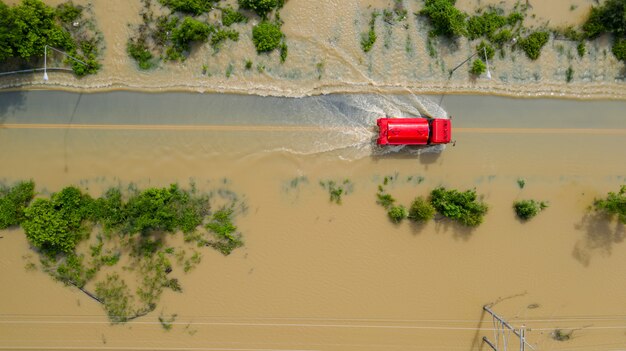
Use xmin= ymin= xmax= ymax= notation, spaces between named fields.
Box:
xmin=0 ymin=91 xmax=626 ymax=350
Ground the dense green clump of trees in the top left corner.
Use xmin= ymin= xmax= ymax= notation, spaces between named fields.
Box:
xmin=0 ymin=0 xmax=101 ymax=76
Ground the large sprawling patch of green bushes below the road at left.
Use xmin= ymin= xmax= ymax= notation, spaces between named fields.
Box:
xmin=0 ymin=181 xmax=244 ymax=323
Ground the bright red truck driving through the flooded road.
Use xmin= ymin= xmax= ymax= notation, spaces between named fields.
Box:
xmin=376 ymin=118 xmax=452 ymax=145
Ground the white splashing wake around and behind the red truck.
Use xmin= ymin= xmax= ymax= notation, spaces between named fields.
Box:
xmin=281 ymin=95 xmax=448 ymax=160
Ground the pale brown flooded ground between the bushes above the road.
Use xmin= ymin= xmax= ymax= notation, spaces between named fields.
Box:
xmin=0 ymin=0 xmax=626 ymax=99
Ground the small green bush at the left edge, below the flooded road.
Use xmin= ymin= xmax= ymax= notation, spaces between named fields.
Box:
xmin=0 ymin=181 xmax=35 ymax=229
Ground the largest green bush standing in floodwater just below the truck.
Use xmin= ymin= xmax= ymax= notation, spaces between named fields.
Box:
xmin=430 ymin=187 xmax=488 ymax=227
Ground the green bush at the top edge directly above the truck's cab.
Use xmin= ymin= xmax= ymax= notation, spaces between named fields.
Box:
xmin=419 ymin=0 xmax=467 ymax=38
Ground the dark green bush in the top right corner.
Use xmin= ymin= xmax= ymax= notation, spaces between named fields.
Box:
xmin=583 ymin=0 xmax=626 ymax=38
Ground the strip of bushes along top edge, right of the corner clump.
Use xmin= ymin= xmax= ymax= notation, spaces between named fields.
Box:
xmin=126 ymin=0 xmax=287 ymax=70
